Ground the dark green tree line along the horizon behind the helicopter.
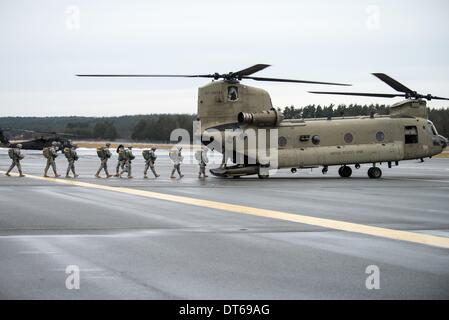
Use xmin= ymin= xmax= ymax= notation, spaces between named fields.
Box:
xmin=0 ymin=104 xmax=449 ymax=142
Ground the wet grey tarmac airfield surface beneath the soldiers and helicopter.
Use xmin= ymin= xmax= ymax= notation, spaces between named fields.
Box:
xmin=0 ymin=149 xmax=449 ymax=299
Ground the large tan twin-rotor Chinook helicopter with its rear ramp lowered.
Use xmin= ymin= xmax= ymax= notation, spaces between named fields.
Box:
xmin=79 ymin=64 xmax=449 ymax=179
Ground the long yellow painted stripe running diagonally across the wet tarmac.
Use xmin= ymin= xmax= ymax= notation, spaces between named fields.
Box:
xmin=3 ymin=172 xmax=449 ymax=249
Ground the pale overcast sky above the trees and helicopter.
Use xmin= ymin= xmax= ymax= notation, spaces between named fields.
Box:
xmin=0 ymin=0 xmax=449 ymax=116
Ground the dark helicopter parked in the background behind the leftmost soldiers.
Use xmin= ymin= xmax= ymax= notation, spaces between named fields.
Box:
xmin=0 ymin=128 xmax=75 ymax=151
